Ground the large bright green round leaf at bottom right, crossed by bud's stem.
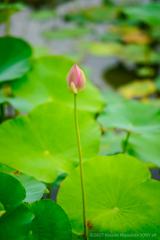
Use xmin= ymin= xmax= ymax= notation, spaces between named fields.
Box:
xmin=58 ymin=154 xmax=160 ymax=237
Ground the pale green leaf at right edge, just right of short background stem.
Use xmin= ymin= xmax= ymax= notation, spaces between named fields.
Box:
xmin=127 ymin=133 xmax=160 ymax=167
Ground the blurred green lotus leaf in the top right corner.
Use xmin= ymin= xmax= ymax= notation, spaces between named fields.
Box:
xmin=122 ymin=3 xmax=160 ymax=26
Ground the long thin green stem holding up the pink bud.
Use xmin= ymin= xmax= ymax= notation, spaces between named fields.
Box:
xmin=74 ymin=94 xmax=88 ymax=240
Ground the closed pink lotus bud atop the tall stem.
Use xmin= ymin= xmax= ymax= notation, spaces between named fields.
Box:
xmin=67 ymin=64 xmax=86 ymax=94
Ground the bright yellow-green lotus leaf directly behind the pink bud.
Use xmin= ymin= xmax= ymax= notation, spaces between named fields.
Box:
xmin=12 ymin=56 xmax=103 ymax=112
